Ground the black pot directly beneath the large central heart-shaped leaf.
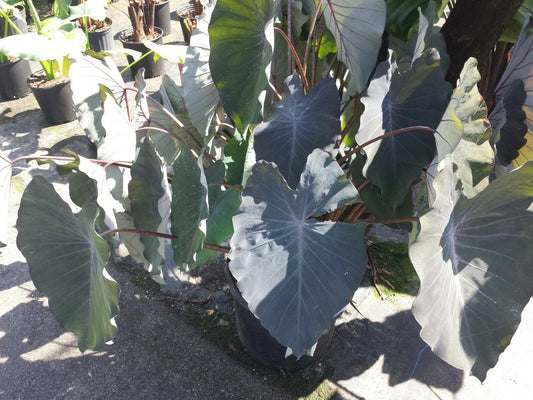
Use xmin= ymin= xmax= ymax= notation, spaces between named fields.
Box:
xmin=224 ymin=265 xmax=334 ymax=371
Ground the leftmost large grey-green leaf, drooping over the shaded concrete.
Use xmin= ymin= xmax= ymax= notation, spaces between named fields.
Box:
xmin=17 ymin=176 xmax=119 ymax=351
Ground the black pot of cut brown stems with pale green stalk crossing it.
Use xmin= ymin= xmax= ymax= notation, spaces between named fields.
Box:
xmin=119 ymin=0 xmax=164 ymax=78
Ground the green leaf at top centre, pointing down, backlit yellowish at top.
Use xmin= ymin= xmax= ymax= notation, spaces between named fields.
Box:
xmin=209 ymin=0 xmax=279 ymax=132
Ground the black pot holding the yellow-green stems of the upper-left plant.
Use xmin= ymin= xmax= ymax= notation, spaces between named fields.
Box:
xmin=28 ymin=72 xmax=76 ymax=125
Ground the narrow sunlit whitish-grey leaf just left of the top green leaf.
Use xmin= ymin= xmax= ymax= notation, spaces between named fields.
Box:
xmin=181 ymin=1 xmax=220 ymax=137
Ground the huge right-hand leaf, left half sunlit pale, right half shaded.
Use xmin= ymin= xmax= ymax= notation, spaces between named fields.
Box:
xmin=409 ymin=159 xmax=533 ymax=380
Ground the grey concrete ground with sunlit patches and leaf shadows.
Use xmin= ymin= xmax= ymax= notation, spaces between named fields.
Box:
xmin=0 ymin=0 xmax=533 ymax=400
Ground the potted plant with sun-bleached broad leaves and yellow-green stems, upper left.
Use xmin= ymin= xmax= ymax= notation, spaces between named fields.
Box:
xmin=0 ymin=0 xmax=86 ymax=124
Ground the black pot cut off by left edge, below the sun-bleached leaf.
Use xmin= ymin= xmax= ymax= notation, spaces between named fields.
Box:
xmin=0 ymin=58 xmax=31 ymax=100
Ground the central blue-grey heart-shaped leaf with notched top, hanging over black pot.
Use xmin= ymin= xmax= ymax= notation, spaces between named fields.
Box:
xmin=230 ymin=150 xmax=367 ymax=357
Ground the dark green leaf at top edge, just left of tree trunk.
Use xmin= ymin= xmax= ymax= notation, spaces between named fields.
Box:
xmin=385 ymin=0 xmax=448 ymax=40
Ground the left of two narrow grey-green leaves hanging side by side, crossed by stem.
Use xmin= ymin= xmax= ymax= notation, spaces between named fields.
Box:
xmin=128 ymin=138 xmax=171 ymax=275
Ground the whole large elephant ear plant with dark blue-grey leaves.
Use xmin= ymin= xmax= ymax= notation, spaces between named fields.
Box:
xmin=0 ymin=0 xmax=533 ymax=380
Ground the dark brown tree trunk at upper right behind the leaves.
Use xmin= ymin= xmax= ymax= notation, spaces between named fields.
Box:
xmin=441 ymin=0 xmax=523 ymax=104
